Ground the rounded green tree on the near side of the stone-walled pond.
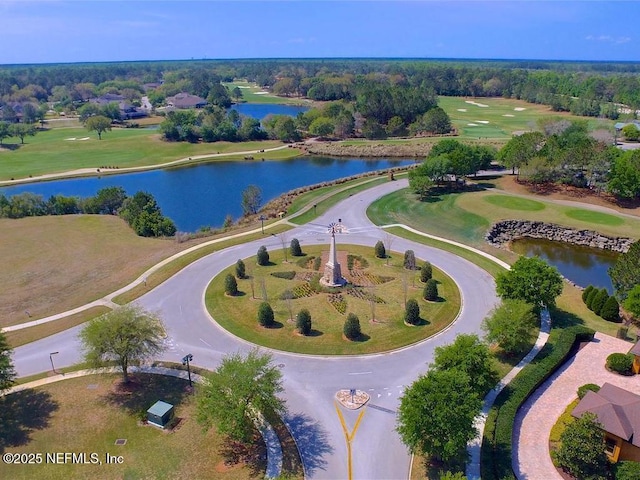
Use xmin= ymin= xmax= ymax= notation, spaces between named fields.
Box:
xmin=496 ymin=257 xmax=563 ymax=311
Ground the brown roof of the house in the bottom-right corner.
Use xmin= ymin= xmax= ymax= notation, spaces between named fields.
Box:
xmin=571 ymin=383 xmax=640 ymax=447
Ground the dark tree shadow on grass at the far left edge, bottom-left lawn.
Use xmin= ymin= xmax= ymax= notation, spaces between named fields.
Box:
xmin=0 ymin=389 xmax=58 ymax=453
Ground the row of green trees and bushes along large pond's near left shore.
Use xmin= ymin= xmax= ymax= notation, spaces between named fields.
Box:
xmin=0 ymin=187 xmax=176 ymax=237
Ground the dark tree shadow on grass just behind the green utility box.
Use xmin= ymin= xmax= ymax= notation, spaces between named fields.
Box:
xmin=101 ymin=373 xmax=189 ymax=419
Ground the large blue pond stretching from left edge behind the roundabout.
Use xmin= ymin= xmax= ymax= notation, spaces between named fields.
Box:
xmin=0 ymin=156 xmax=415 ymax=232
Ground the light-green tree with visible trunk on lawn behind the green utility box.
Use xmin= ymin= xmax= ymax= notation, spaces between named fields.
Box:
xmin=80 ymin=304 xmax=166 ymax=383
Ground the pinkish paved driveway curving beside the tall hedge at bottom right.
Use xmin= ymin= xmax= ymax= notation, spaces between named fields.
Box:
xmin=512 ymin=332 xmax=640 ymax=480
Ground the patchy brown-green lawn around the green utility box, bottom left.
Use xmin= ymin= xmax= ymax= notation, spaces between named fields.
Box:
xmin=0 ymin=375 xmax=265 ymax=480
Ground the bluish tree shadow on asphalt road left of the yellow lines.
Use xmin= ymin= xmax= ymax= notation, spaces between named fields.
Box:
xmin=284 ymin=413 xmax=333 ymax=477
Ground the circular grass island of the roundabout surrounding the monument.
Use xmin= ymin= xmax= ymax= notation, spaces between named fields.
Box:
xmin=205 ymin=244 xmax=460 ymax=355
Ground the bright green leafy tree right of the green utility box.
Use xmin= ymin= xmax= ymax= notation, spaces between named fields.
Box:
xmin=197 ymin=350 xmax=285 ymax=443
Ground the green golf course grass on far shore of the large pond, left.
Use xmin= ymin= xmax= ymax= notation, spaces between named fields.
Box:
xmin=0 ymin=128 xmax=290 ymax=181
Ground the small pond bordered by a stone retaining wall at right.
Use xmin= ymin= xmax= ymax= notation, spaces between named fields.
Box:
xmin=511 ymin=238 xmax=618 ymax=294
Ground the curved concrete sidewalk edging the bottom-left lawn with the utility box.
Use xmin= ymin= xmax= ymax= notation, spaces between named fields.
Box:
xmin=0 ymin=367 xmax=283 ymax=478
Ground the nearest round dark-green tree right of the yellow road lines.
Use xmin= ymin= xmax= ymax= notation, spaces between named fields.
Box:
xmin=396 ymin=369 xmax=482 ymax=462
